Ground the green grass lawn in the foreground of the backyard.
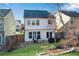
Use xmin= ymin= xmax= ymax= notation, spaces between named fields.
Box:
xmin=0 ymin=43 xmax=79 ymax=56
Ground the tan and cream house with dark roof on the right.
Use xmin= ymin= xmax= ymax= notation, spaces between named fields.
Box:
xmin=55 ymin=11 xmax=79 ymax=38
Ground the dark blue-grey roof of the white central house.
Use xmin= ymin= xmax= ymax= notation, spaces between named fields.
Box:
xmin=24 ymin=10 xmax=54 ymax=18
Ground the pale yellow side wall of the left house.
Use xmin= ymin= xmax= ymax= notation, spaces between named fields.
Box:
xmin=4 ymin=11 xmax=16 ymax=36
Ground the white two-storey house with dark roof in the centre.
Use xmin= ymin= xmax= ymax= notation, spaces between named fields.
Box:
xmin=24 ymin=10 xmax=55 ymax=42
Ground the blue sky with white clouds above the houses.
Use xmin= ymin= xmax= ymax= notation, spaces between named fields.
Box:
xmin=0 ymin=3 xmax=79 ymax=23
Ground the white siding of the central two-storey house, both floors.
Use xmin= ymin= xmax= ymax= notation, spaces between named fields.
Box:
xmin=25 ymin=18 xmax=55 ymax=42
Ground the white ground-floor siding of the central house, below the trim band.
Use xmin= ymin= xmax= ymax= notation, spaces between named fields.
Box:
xmin=25 ymin=29 xmax=54 ymax=41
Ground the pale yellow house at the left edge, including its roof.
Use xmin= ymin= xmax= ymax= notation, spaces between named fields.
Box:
xmin=0 ymin=9 xmax=16 ymax=50
